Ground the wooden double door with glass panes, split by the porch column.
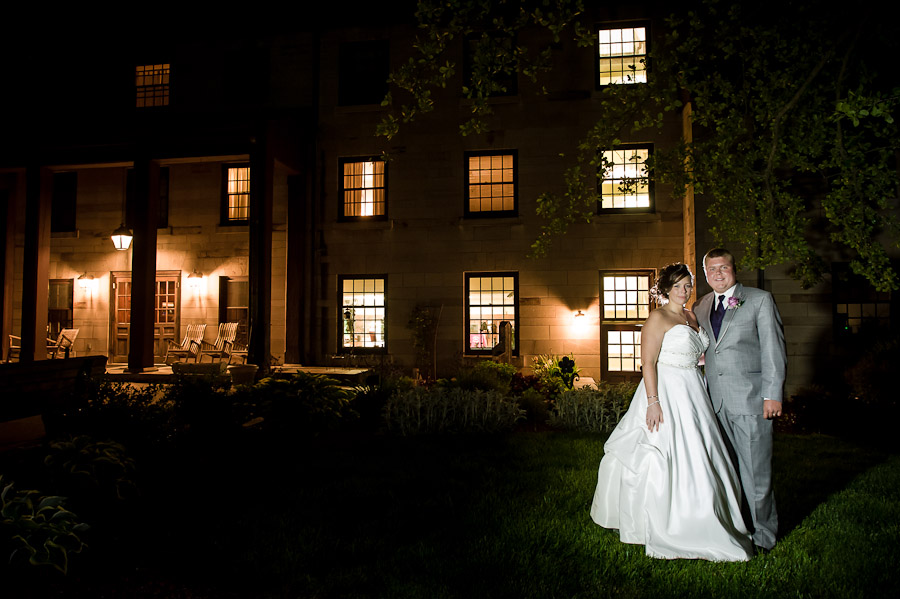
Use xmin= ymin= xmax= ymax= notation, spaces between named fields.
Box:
xmin=109 ymin=271 xmax=181 ymax=363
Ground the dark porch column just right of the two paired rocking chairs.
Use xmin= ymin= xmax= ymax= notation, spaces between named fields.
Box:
xmin=247 ymin=130 xmax=274 ymax=371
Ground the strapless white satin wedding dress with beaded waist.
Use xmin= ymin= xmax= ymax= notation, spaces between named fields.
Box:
xmin=591 ymin=325 xmax=753 ymax=561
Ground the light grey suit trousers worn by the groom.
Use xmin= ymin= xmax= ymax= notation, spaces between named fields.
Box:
xmin=717 ymin=408 xmax=778 ymax=549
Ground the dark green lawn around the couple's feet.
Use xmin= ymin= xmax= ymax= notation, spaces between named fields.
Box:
xmin=8 ymin=432 xmax=900 ymax=599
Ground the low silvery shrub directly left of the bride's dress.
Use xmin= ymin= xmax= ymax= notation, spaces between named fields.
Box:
xmin=550 ymin=381 xmax=637 ymax=433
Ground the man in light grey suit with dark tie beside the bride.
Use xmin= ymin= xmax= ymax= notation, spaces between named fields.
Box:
xmin=694 ymin=248 xmax=787 ymax=550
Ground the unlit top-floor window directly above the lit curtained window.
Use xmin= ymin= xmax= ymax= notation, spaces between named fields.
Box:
xmin=338 ymin=40 xmax=390 ymax=106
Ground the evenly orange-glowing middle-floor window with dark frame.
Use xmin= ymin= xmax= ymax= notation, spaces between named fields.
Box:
xmin=466 ymin=152 xmax=517 ymax=216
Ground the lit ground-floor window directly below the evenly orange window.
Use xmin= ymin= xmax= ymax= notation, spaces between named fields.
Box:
xmin=466 ymin=273 xmax=519 ymax=355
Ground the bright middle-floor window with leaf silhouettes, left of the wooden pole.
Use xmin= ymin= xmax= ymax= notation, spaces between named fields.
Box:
xmin=600 ymin=146 xmax=653 ymax=212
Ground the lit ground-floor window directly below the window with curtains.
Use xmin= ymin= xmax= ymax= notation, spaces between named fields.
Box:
xmin=338 ymin=277 xmax=386 ymax=350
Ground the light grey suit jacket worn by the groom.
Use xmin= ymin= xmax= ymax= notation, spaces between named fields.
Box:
xmin=694 ymin=283 xmax=787 ymax=415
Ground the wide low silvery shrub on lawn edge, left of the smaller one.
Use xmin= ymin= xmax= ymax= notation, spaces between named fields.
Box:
xmin=384 ymin=387 xmax=525 ymax=435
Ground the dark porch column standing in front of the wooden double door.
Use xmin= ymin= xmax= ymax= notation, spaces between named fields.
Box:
xmin=128 ymin=155 xmax=159 ymax=372
